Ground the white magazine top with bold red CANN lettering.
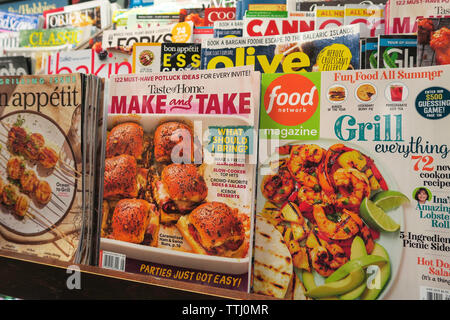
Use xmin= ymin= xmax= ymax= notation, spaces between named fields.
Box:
xmin=243 ymin=17 xmax=314 ymax=37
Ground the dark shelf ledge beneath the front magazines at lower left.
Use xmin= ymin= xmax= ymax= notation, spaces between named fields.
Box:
xmin=0 ymin=250 xmax=269 ymax=300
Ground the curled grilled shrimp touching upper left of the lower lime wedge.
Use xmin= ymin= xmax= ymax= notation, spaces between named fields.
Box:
xmin=333 ymin=168 xmax=371 ymax=210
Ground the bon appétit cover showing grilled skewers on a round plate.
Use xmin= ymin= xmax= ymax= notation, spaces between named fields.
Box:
xmin=0 ymin=74 xmax=85 ymax=262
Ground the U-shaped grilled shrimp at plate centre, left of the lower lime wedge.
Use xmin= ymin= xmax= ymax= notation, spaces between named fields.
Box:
xmin=313 ymin=205 xmax=363 ymax=240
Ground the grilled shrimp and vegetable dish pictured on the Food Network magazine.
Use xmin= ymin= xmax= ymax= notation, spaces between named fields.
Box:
xmin=254 ymin=140 xmax=402 ymax=300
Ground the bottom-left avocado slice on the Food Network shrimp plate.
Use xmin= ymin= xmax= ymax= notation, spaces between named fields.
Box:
xmin=306 ymin=268 xmax=366 ymax=298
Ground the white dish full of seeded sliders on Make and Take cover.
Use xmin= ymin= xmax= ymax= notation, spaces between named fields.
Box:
xmin=101 ymin=115 xmax=251 ymax=274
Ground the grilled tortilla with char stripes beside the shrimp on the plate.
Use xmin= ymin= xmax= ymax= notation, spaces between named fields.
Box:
xmin=253 ymin=216 xmax=293 ymax=299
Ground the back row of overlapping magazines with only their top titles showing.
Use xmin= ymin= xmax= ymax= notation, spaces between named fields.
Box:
xmin=0 ymin=1 xmax=450 ymax=77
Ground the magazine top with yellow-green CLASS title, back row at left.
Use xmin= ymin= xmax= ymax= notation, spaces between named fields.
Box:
xmin=19 ymin=27 xmax=95 ymax=48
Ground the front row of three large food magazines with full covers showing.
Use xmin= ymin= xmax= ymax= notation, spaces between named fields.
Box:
xmin=0 ymin=62 xmax=450 ymax=299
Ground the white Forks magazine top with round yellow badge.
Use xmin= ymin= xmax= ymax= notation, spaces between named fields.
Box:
xmin=102 ymin=22 xmax=194 ymax=54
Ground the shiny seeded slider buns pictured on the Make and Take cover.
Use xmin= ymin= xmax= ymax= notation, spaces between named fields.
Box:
xmin=102 ymin=116 xmax=250 ymax=258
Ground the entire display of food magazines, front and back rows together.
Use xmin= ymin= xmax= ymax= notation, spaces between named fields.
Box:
xmin=0 ymin=0 xmax=450 ymax=300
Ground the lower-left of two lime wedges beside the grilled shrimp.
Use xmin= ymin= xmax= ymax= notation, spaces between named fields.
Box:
xmin=359 ymin=198 xmax=400 ymax=232
